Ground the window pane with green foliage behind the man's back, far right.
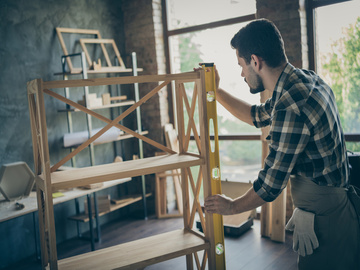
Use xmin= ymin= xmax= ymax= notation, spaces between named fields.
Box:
xmin=316 ymin=1 xmax=360 ymax=151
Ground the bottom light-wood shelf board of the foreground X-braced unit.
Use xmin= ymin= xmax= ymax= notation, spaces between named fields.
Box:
xmin=58 ymin=230 xmax=210 ymax=270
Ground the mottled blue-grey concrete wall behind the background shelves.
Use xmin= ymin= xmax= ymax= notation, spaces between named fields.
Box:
xmin=0 ymin=0 xmax=132 ymax=268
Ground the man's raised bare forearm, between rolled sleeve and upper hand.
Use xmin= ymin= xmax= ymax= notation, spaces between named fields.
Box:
xmin=216 ymin=88 xmax=254 ymax=126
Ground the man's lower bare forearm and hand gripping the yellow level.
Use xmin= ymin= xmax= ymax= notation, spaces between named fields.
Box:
xmin=205 ymin=187 xmax=265 ymax=215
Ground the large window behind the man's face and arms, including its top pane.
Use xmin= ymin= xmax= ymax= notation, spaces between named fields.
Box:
xmin=166 ymin=0 xmax=262 ymax=182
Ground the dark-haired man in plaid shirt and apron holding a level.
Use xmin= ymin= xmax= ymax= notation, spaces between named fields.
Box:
xmin=205 ymin=19 xmax=360 ymax=270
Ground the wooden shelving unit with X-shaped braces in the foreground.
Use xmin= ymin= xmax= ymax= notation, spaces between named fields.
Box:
xmin=27 ymin=71 xmax=223 ymax=270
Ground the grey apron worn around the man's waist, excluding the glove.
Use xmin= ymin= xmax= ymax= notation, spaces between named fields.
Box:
xmin=290 ymin=175 xmax=360 ymax=270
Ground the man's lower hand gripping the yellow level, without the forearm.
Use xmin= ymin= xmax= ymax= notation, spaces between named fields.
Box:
xmin=205 ymin=194 xmax=234 ymax=215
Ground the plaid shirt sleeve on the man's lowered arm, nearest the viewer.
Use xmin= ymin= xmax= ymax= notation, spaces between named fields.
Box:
xmin=253 ymin=110 xmax=310 ymax=202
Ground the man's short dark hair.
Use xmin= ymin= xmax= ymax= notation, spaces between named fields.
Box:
xmin=231 ymin=19 xmax=287 ymax=68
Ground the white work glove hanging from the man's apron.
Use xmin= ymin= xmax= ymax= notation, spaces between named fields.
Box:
xmin=285 ymin=208 xmax=319 ymax=256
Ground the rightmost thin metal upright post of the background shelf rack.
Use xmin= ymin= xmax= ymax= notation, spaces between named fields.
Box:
xmin=131 ymin=52 xmax=147 ymax=220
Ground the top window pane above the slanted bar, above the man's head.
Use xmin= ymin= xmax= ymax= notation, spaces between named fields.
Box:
xmin=166 ymin=0 xmax=256 ymax=30
